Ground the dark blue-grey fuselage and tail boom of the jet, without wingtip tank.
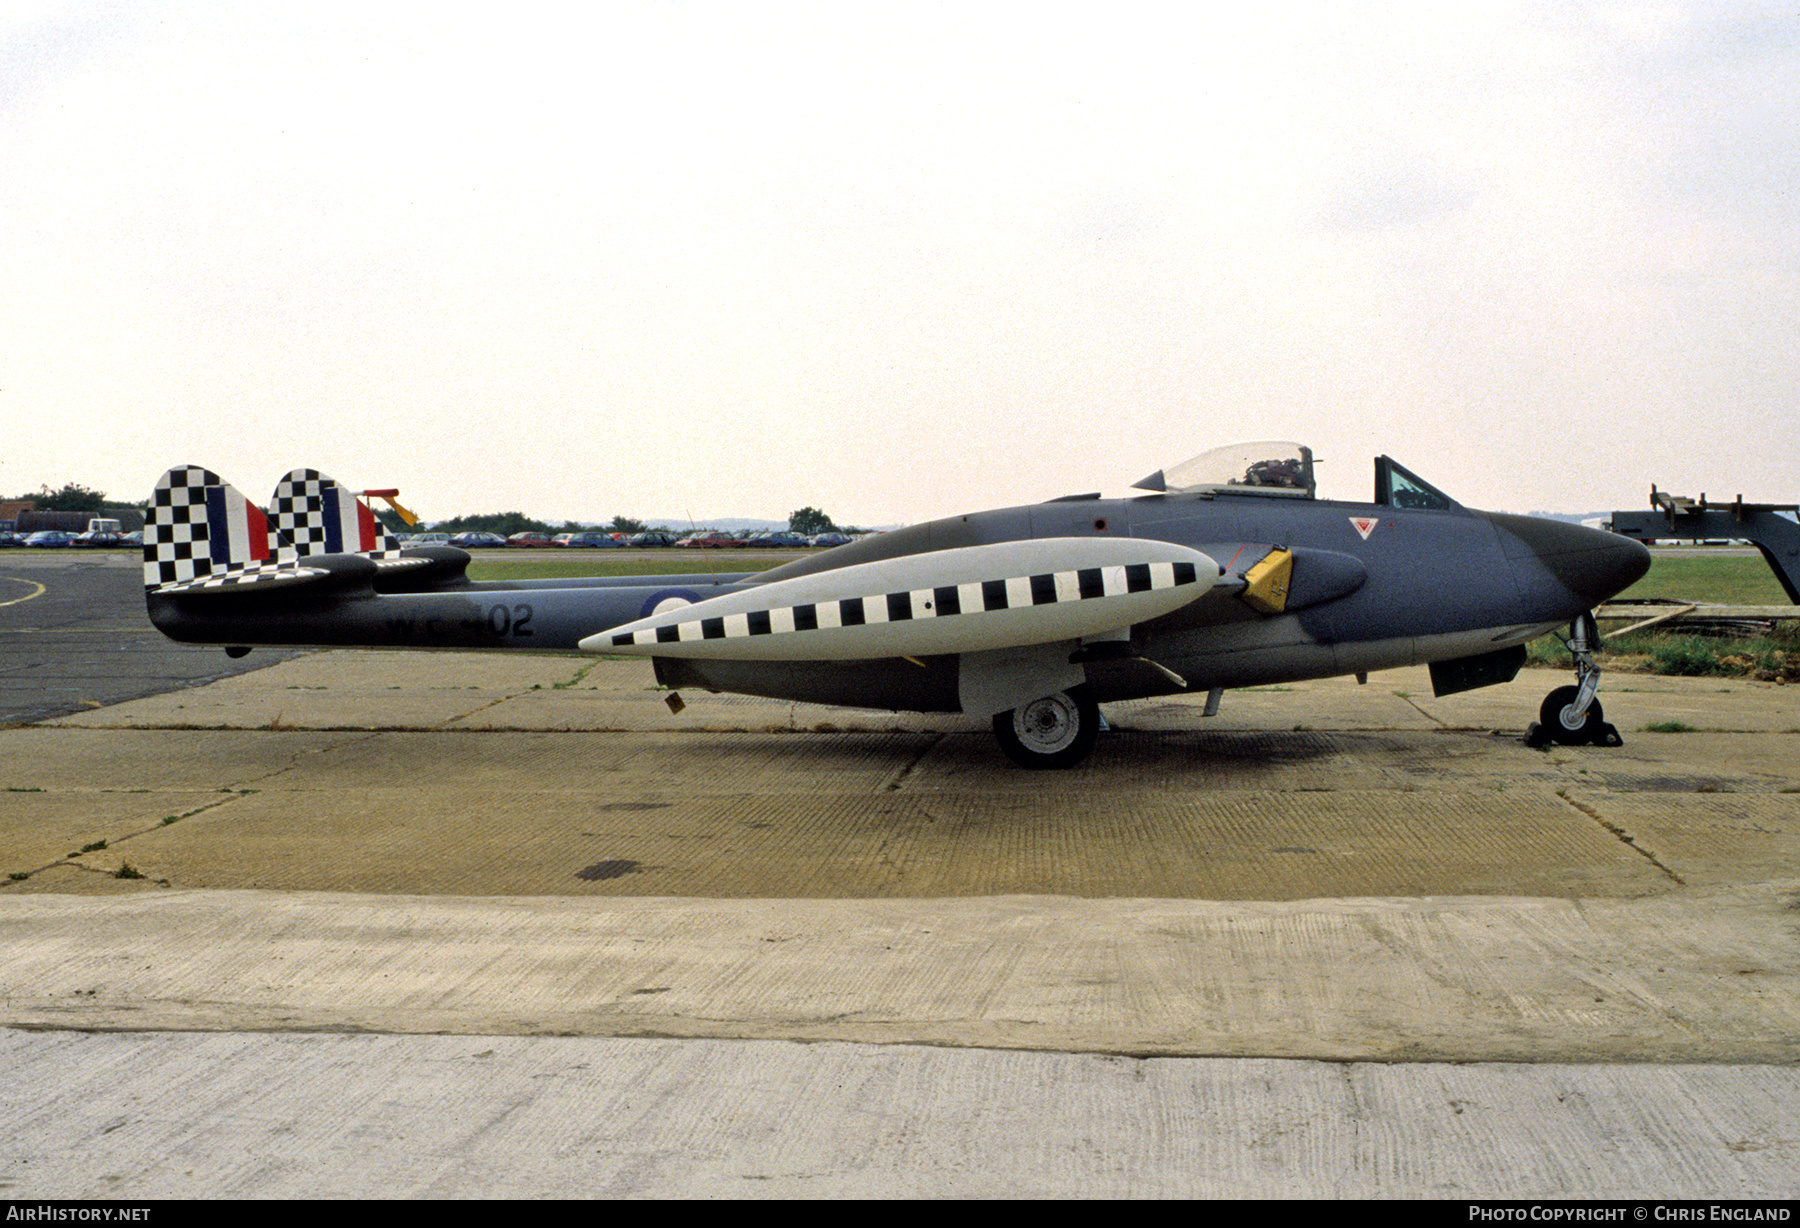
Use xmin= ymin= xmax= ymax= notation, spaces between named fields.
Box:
xmin=149 ymin=492 xmax=1649 ymax=711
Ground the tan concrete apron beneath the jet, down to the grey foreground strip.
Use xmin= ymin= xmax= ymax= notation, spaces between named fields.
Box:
xmin=0 ymin=654 xmax=1800 ymax=1062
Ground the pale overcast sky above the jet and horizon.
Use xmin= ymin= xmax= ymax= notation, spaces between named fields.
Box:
xmin=0 ymin=0 xmax=1800 ymax=524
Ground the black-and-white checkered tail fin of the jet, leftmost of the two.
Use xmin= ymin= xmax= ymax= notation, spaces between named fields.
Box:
xmin=144 ymin=465 xmax=324 ymax=592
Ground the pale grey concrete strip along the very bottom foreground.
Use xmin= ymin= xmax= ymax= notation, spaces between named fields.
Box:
xmin=0 ymin=1034 xmax=1800 ymax=1199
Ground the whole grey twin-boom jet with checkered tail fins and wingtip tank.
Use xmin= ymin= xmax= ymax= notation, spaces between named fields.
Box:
xmin=144 ymin=443 xmax=1651 ymax=767
